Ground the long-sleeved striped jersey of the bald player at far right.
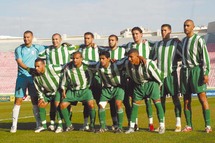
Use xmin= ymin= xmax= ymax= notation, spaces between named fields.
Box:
xmin=182 ymin=34 xmax=210 ymax=75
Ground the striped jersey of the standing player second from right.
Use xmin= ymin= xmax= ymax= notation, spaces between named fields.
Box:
xmin=153 ymin=39 xmax=182 ymax=78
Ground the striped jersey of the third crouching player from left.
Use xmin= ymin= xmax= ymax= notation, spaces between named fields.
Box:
xmin=89 ymin=62 xmax=122 ymax=87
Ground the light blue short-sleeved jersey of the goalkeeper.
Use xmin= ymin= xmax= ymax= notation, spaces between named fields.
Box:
xmin=15 ymin=44 xmax=45 ymax=76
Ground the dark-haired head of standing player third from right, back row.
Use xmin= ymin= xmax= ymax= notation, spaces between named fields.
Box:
xmin=131 ymin=27 xmax=143 ymax=44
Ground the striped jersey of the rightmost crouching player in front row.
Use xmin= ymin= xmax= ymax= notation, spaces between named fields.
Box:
xmin=124 ymin=59 xmax=163 ymax=86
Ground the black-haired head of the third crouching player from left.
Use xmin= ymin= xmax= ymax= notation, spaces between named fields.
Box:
xmin=99 ymin=51 xmax=110 ymax=68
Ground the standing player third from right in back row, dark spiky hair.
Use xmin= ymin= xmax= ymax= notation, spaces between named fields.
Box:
xmin=126 ymin=27 xmax=154 ymax=131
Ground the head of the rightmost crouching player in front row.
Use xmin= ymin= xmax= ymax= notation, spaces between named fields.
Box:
xmin=128 ymin=49 xmax=140 ymax=65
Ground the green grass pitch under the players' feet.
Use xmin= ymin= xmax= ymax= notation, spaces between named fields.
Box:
xmin=0 ymin=97 xmax=215 ymax=143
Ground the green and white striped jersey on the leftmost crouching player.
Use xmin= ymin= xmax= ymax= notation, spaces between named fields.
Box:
xmin=34 ymin=65 xmax=62 ymax=98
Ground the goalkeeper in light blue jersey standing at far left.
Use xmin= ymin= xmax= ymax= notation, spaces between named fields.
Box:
xmin=10 ymin=31 xmax=45 ymax=133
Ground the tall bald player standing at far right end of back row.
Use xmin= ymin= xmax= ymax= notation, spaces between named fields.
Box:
xmin=181 ymin=19 xmax=212 ymax=133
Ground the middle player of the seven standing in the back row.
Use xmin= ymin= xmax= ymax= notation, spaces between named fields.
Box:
xmin=108 ymin=35 xmax=131 ymax=130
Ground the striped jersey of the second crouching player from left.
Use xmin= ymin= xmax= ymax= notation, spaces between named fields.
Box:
xmin=61 ymin=62 xmax=93 ymax=90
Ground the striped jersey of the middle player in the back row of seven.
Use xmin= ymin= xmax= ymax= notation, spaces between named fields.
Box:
xmin=109 ymin=46 xmax=126 ymax=60
